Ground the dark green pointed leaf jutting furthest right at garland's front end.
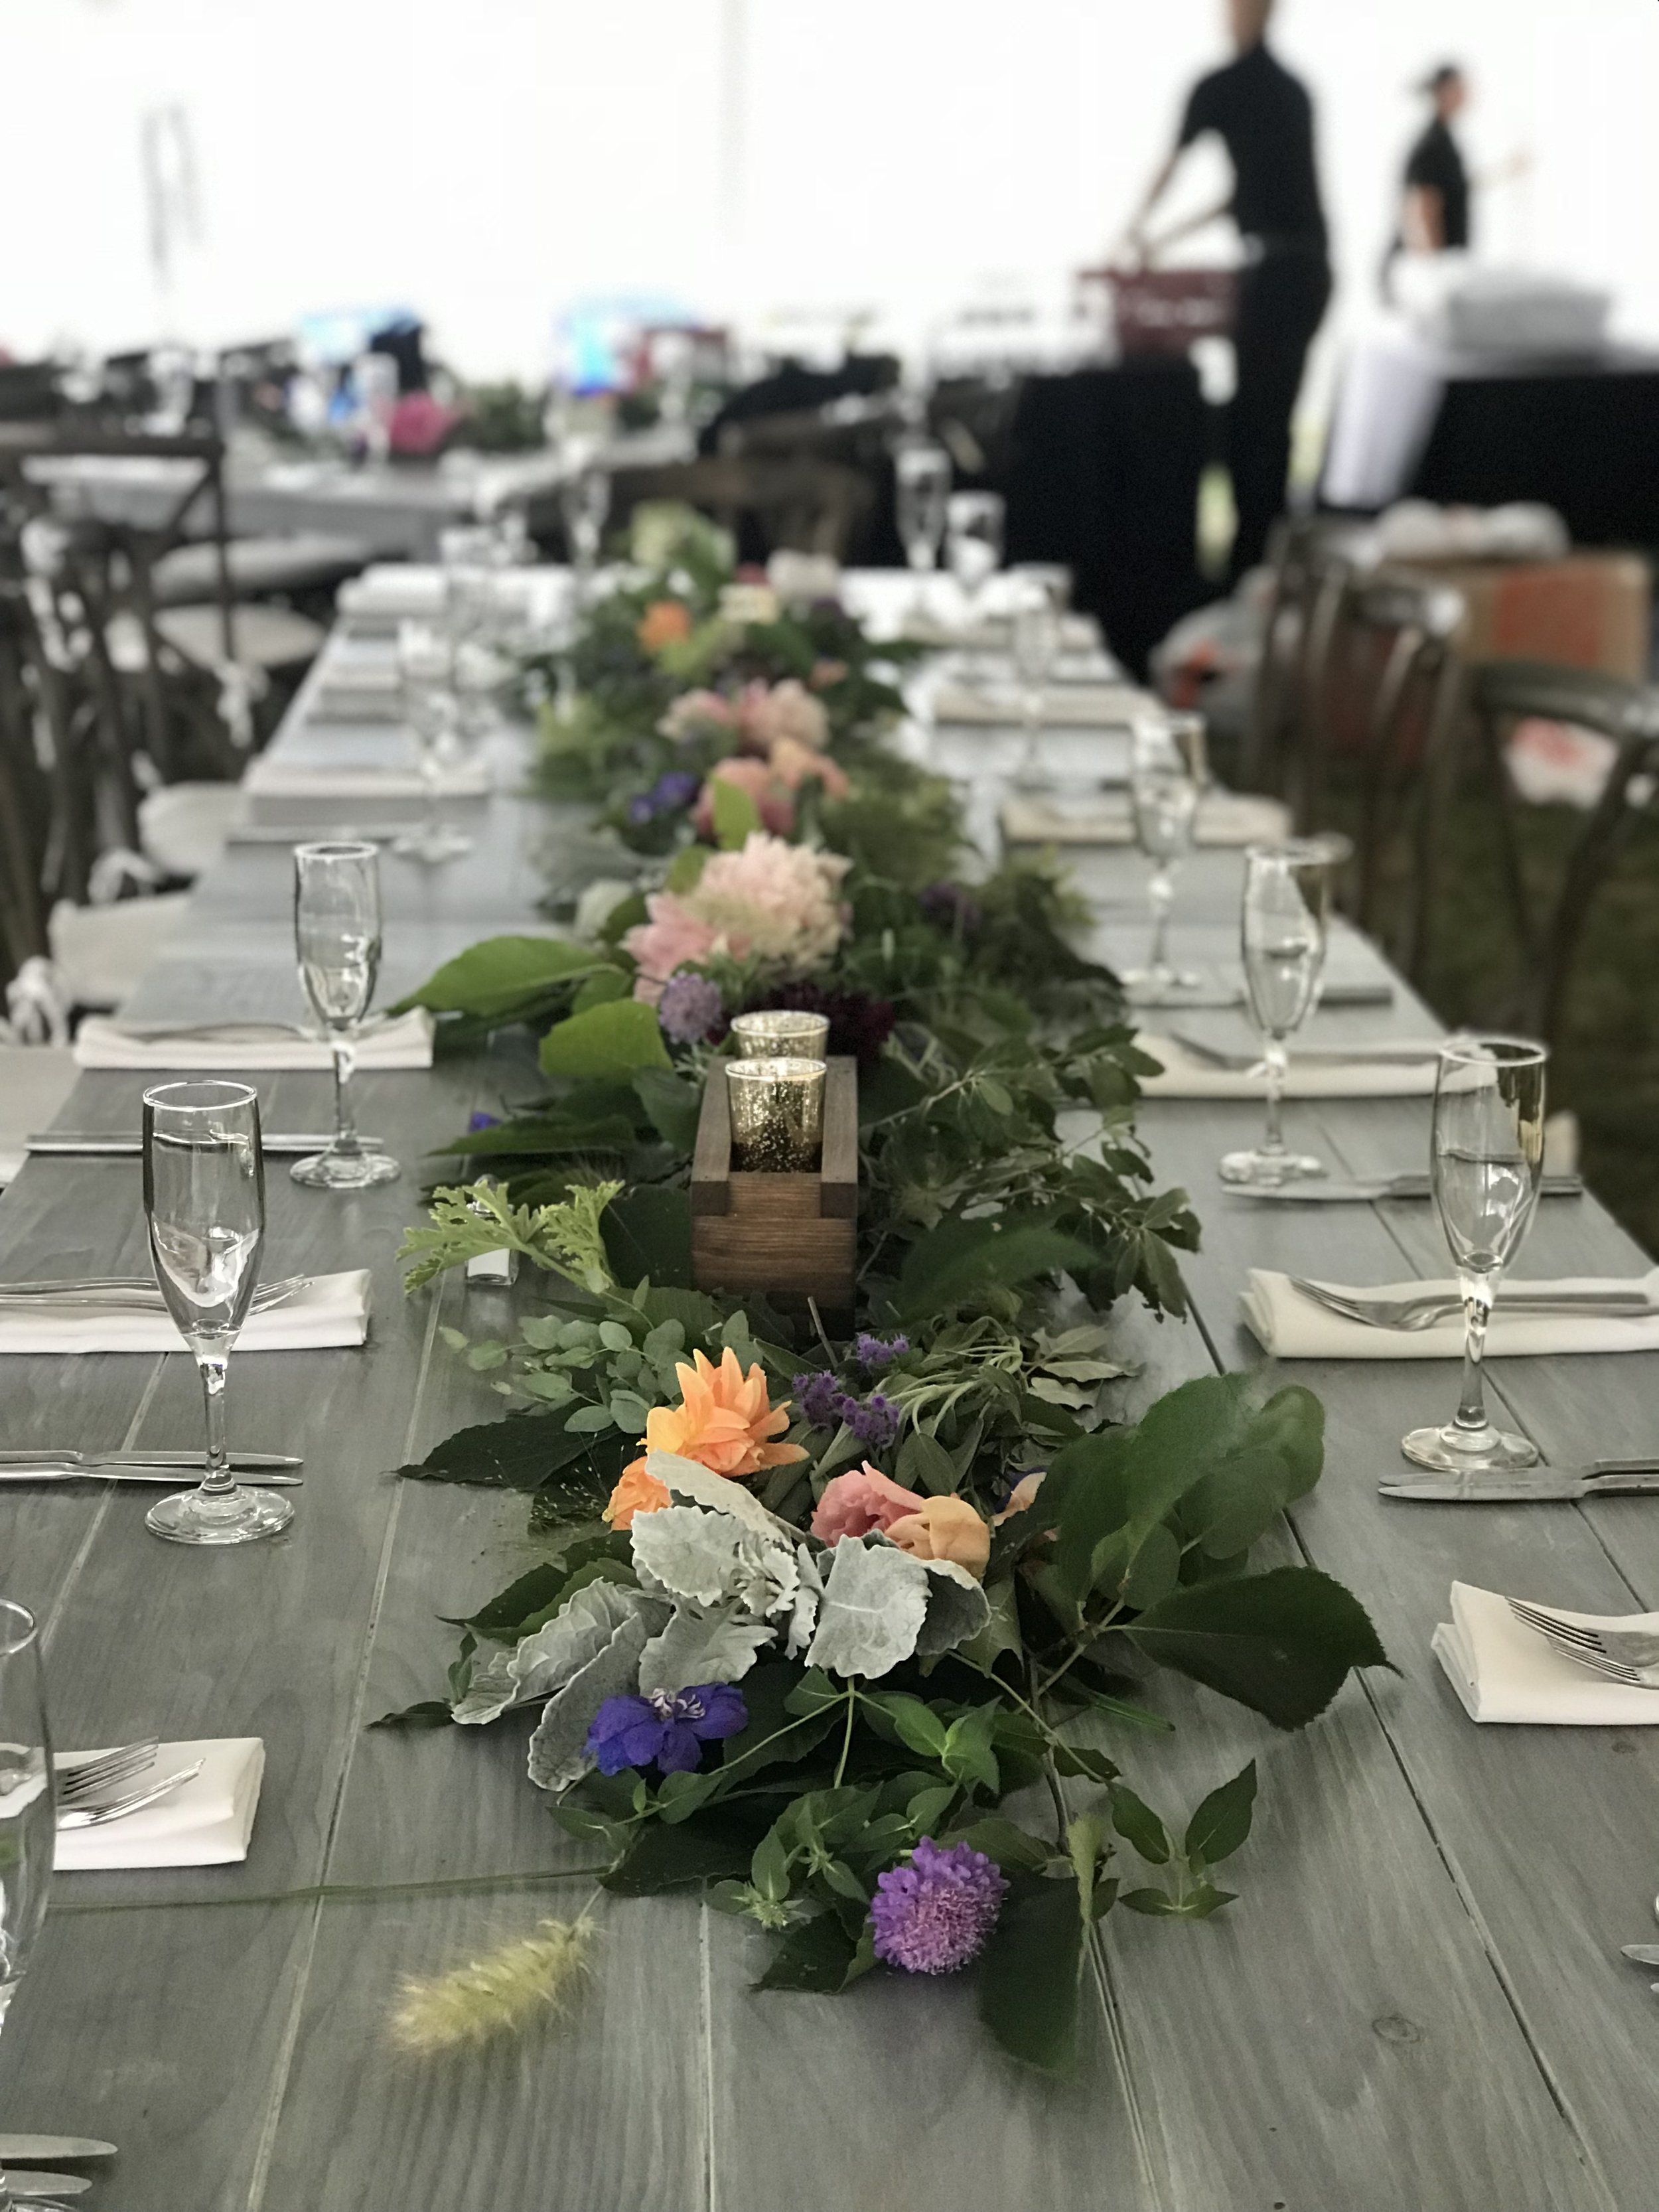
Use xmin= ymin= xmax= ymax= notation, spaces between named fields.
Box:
xmin=1128 ymin=1566 xmax=1392 ymax=1728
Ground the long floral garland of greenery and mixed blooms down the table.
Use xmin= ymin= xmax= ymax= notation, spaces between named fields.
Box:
xmin=387 ymin=508 xmax=1387 ymax=2071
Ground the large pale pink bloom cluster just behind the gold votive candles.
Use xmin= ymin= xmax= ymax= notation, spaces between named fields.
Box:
xmin=622 ymin=830 xmax=851 ymax=1007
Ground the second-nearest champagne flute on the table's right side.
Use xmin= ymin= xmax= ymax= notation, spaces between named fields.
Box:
xmin=1221 ymin=838 xmax=1345 ymax=1190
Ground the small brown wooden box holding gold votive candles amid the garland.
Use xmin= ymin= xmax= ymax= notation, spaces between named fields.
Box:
xmin=690 ymin=1060 xmax=858 ymax=1331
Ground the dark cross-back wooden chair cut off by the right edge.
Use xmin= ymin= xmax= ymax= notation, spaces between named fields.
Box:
xmin=1469 ymin=662 xmax=1659 ymax=1044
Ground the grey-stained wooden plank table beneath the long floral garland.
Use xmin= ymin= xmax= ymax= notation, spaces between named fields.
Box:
xmin=0 ymin=606 xmax=1659 ymax=2212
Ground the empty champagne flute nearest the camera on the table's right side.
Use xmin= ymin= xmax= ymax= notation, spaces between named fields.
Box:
xmin=1400 ymin=1037 xmax=1548 ymax=1473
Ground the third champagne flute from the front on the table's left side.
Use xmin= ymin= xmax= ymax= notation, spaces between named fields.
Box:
xmin=287 ymin=845 xmax=400 ymax=1190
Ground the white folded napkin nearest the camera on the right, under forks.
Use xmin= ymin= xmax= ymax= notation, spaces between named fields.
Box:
xmin=1431 ymin=1582 xmax=1659 ymax=1728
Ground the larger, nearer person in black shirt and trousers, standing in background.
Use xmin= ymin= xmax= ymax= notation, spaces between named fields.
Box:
xmin=1128 ymin=0 xmax=1332 ymax=582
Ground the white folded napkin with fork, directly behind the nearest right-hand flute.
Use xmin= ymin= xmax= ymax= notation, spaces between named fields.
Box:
xmin=1239 ymin=1268 xmax=1659 ymax=1361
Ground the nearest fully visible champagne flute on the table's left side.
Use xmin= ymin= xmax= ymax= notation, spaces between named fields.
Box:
xmin=144 ymin=1082 xmax=294 ymax=1544
